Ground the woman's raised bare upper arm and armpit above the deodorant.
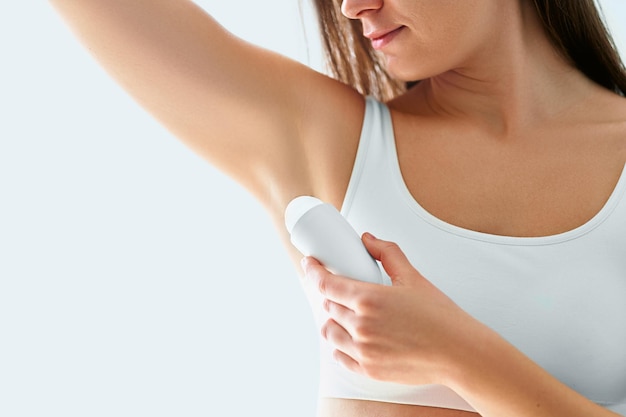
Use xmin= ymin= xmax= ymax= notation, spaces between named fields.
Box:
xmin=50 ymin=0 xmax=362 ymax=208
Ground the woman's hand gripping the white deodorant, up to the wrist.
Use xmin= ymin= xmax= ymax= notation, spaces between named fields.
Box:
xmin=303 ymin=234 xmax=485 ymax=384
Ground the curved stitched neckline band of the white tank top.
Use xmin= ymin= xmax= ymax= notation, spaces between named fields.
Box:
xmin=379 ymin=98 xmax=626 ymax=246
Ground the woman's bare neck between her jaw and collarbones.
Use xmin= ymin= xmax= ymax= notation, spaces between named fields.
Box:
xmin=409 ymin=2 xmax=594 ymax=138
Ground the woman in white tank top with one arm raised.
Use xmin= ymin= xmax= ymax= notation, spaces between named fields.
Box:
xmin=51 ymin=0 xmax=626 ymax=417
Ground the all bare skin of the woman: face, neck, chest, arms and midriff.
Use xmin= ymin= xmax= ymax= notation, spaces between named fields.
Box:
xmin=49 ymin=0 xmax=626 ymax=417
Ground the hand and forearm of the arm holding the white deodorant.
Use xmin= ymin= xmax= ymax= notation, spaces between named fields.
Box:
xmin=303 ymin=234 xmax=618 ymax=417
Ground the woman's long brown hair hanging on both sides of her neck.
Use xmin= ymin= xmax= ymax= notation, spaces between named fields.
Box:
xmin=314 ymin=0 xmax=626 ymax=100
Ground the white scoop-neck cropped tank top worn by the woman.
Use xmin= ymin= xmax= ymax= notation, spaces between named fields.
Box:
xmin=309 ymin=98 xmax=626 ymax=416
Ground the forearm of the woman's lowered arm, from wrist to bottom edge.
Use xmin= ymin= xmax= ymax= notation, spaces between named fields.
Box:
xmin=448 ymin=329 xmax=619 ymax=417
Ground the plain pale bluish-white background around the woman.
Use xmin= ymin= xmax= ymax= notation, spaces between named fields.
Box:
xmin=0 ymin=0 xmax=626 ymax=417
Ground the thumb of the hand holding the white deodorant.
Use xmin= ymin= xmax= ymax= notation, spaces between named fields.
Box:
xmin=362 ymin=233 xmax=421 ymax=285
